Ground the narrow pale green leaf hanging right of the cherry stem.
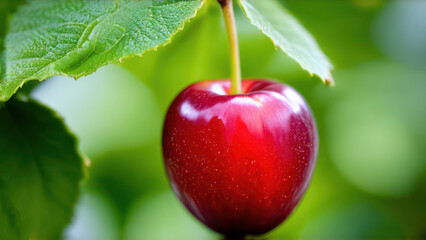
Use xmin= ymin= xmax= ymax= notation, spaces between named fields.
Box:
xmin=239 ymin=0 xmax=333 ymax=84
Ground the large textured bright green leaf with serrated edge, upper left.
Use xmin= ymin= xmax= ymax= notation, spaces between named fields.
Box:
xmin=0 ymin=0 xmax=203 ymax=101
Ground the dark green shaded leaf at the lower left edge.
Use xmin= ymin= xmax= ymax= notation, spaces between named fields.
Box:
xmin=0 ymin=99 xmax=83 ymax=240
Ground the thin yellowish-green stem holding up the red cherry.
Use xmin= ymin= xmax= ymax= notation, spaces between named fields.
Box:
xmin=218 ymin=0 xmax=241 ymax=94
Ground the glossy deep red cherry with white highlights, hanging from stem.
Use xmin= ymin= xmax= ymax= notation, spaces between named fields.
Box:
xmin=163 ymin=80 xmax=318 ymax=236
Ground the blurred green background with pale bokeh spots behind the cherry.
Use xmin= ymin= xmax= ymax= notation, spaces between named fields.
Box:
xmin=32 ymin=0 xmax=426 ymax=240
